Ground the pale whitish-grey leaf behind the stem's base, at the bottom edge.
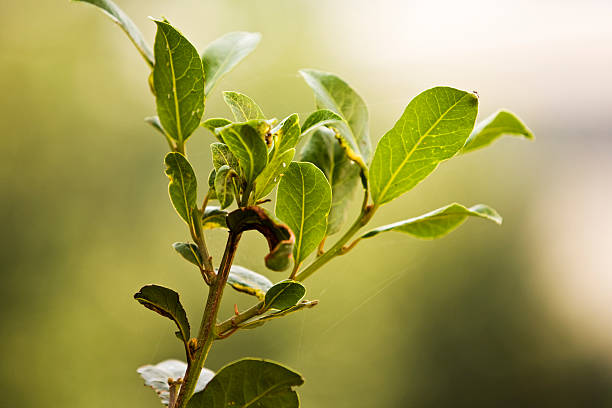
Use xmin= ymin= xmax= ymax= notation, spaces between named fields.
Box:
xmin=136 ymin=360 xmax=215 ymax=405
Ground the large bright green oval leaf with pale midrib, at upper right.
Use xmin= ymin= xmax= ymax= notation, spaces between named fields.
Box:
xmin=370 ymin=87 xmax=478 ymax=205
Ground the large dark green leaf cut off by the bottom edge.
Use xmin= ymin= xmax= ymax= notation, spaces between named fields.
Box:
xmin=187 ymin=358 xmax=304 ymax=408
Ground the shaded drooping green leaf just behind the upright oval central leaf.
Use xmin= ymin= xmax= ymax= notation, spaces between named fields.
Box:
xmin=300 ymin=128 xmax=359 ymax=235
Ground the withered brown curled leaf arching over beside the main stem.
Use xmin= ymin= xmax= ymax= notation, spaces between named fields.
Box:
xmin=227 ymin=206 xmax=295 ymax=271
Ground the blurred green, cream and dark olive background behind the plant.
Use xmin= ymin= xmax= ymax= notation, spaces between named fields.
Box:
xmin=0 ymin=0 xmax=612 ymax=408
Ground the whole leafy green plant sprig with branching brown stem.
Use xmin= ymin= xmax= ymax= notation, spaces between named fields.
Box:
xmin=77 ymin=0 xmax=533 ymax=408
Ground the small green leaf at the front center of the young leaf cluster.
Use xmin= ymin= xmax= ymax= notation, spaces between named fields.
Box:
xmin=219 ymin=121 xmax=270 ymax=183
